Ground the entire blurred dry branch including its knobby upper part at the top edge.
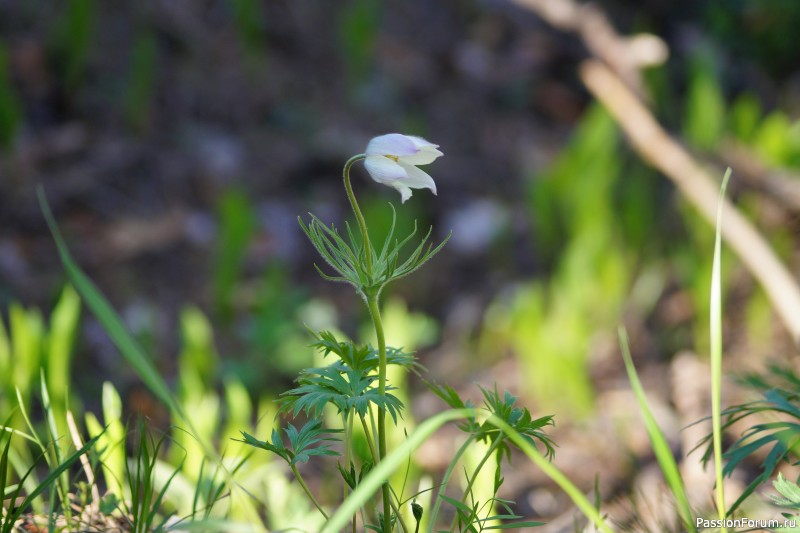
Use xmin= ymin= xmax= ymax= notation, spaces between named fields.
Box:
xmin=513 ymin=0 xmax=800 ymax=347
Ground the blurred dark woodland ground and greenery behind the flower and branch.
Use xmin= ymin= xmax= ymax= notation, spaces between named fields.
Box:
xmin=0 ymin=0 xmax=800 ymax=528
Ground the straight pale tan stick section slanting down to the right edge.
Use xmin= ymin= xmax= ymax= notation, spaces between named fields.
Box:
xmin=580 ymin=60 xmax=800 ymax=346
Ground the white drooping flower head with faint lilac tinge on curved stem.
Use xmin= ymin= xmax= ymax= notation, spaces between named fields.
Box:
xmin=364 ymin=133 xmax=444 ymax=202
